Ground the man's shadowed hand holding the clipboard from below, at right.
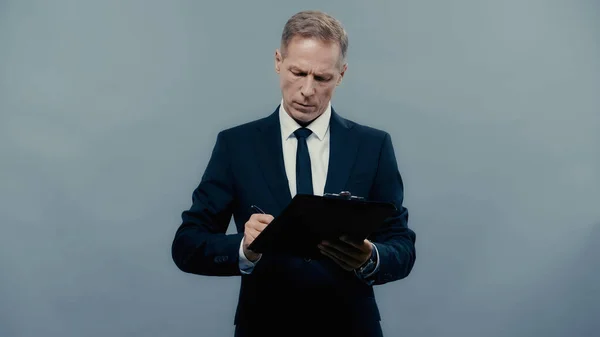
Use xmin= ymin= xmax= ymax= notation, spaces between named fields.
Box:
xmin=318 ymin=236 xmax=373 ymax=271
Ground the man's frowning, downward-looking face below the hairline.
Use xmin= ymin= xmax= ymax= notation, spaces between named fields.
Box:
xmin=275 ymin=37 xmax=347 ymax=123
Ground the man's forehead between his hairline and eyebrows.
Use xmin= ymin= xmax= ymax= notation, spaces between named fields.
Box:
xmin=285 ymin=37 xmax=341 ymax=72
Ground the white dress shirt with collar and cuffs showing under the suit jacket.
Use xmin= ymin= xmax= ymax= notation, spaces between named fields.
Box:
xmin=239 ymin=100 xmax=379 ymax=274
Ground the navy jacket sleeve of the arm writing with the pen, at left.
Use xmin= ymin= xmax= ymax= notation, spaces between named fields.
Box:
xmin=171 ymin=132 xmax=243 ymax=276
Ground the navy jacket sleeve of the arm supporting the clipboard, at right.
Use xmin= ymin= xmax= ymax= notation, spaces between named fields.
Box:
xmin=367 ymin=133 xmax=416 ymax=285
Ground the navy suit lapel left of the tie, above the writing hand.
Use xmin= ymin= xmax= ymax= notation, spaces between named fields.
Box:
xmin=256 ymin=107 xmax=292 ymax=209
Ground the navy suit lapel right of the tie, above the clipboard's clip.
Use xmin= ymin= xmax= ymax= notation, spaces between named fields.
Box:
xmin=325 ymin=108 xmax=359 ymax=193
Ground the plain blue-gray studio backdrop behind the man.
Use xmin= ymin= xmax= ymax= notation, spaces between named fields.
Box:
xmin=0 ymin=0 xmax=600 ymax=337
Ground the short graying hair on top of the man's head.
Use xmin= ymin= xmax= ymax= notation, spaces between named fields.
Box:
xmin=281 ymin=10 xmax=348 ymax=64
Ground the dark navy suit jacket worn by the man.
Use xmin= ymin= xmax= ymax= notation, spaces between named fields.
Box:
xmin=172 ymin=109 xmax=415 ymax=332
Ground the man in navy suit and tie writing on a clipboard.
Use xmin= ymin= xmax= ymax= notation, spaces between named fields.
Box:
xmin=172 ymin=11 xmax=415 ymax=336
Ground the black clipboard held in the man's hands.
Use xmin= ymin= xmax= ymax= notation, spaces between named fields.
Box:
xmin=248 ymin=191 xmax=396 ymax=260
